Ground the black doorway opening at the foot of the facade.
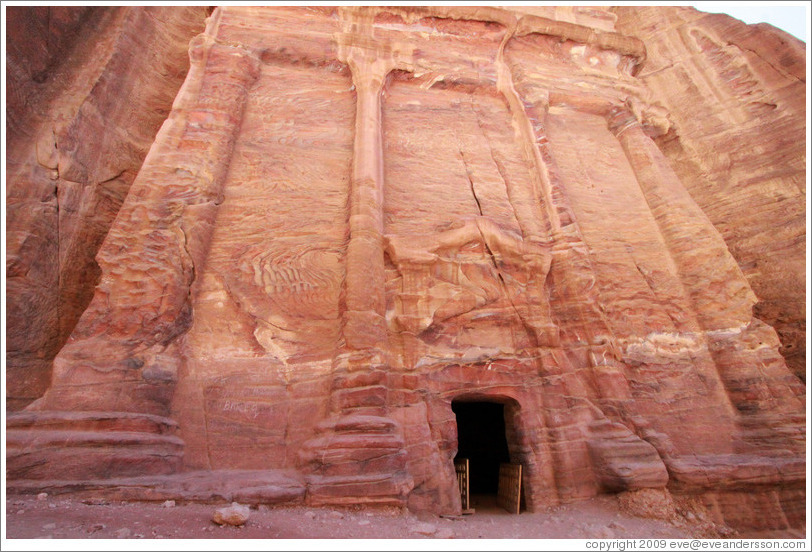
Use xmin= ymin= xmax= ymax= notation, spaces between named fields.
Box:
xmin=451 ymin=401 xmax=510 ymax=495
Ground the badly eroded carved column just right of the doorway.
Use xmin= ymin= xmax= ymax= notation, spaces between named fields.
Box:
xmin=522 ymin=94 xmax=668 ymax=503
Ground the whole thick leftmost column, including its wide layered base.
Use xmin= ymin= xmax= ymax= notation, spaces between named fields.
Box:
xmin=7 ymin=28 xmax=259 ymax=481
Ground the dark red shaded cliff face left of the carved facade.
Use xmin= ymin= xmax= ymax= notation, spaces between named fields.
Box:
xmin=5 ymin=7 xmax=206 ymax=409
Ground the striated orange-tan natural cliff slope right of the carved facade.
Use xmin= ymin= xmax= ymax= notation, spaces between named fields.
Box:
xmin=614 ymin=7 xmax=808 ymax=380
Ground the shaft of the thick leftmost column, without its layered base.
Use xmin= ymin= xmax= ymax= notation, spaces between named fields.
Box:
xmin=30 ymin=34 xmax=259 ymax=415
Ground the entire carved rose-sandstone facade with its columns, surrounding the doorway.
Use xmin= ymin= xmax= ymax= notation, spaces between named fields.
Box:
xmin=8 ymin=7 xmax=805 ymax=530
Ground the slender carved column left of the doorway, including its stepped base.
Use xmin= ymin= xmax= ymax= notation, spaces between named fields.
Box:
xmin=299 ymin=12 xmax=414 ymax=506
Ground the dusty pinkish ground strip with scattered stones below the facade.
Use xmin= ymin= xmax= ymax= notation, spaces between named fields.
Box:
xmin=6 ymin=495 xmax=772 ymax=549
